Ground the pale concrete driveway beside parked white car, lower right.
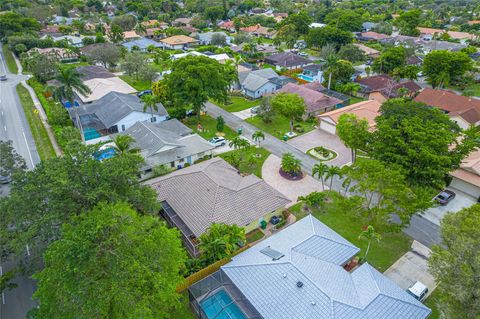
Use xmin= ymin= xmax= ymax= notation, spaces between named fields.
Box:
xmin=384 ymin=240 xmax=436 ymax=300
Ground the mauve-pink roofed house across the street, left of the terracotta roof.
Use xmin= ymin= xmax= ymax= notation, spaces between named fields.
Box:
xmin=278 ymin=83 xmax=342 ymax=117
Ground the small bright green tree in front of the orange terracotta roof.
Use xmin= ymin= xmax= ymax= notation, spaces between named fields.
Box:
xmin=337 ymin=113 xmax=370 ymax=163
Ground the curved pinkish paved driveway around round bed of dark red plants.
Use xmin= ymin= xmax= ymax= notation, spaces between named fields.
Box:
xmin=262 ymin=155 xmax=322 ymax=205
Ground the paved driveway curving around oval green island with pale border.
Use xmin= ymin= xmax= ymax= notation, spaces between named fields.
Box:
xmin=287 ymin=129 xmax=352 ymax=166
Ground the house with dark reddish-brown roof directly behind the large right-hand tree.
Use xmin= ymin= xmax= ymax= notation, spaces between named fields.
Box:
xmin=356 ymin=74 xmax=421 ymax=102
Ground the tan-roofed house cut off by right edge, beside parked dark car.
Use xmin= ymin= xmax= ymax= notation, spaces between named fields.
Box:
xmin=449 ymin=150 xmax=480 ymax=198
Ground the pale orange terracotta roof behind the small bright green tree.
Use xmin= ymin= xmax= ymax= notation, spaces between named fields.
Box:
xmin=318 ymin=100 xmax=382 ymax=128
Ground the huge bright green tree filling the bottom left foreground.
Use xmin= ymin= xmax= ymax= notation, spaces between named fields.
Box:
xmin=33 ymin=203 xmax=186 ymax=319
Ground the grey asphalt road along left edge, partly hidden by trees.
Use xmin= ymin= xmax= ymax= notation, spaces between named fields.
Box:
xmin=0 ymin=44 xmax=40 ymax=319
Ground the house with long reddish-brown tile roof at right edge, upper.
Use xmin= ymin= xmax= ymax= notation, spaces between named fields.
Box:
xmin=415 ymin=88 xmax=480 ymax=129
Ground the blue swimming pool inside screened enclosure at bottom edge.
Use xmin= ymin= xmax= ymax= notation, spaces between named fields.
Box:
xmin=200 ymin=290 xmax=246 ymax=319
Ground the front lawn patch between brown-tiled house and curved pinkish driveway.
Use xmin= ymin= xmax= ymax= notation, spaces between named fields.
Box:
xmin=219 ymin=146 xmax=270 ymax=178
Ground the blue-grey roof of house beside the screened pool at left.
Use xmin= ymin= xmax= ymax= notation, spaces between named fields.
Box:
xmin=77 ymin=92 xmax=168 ymax=128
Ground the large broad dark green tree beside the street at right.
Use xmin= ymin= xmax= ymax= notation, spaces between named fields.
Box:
xmin=369 ymin=99 xmax=476 ymax=187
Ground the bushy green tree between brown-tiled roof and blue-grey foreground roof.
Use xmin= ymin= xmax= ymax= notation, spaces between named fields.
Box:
xmin=199 ymin=223 xmax=246 ymax=265
